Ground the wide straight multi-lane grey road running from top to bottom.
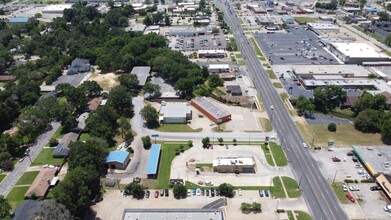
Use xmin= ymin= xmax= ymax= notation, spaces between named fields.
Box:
xmin=217 ymin=0 xmax=348 ymax=220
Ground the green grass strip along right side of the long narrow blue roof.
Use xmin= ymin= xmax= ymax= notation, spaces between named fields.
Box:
xmin=142 ymin=144 xmax=193 ymax=189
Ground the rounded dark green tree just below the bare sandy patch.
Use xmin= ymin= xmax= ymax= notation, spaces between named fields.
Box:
xmin=108 ymin=86 xmax=133 ymax=116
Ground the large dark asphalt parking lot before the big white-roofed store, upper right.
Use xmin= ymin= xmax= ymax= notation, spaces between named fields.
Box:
xmin=254 ymin=26 xmax=338 ymax=65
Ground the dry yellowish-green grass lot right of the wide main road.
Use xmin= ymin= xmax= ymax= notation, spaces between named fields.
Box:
xmin=298 ymin=123 xmax=383 ymax=147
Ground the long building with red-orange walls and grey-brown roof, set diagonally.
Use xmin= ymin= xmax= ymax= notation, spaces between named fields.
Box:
xmin=191 ymin=97 xmax=231 ymax=124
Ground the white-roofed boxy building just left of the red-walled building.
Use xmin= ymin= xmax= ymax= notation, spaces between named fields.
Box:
xmin=159 ymin=102 xmax=191 ymax=124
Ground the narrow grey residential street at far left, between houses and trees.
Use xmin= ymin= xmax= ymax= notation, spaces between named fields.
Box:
xmin=0 ymin=122 xmax=60 ymax=196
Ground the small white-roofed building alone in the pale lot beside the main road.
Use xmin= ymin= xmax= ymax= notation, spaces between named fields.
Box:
xmin=213 ymin=157 xmax=256 ymax=173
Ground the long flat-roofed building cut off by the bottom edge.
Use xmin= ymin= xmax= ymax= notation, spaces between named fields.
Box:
xmin=122 ymin=209 xmax=224 ymax=220
